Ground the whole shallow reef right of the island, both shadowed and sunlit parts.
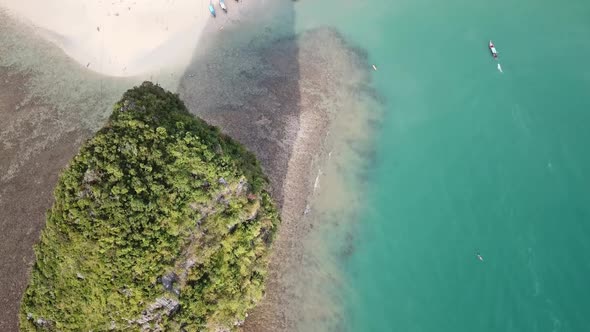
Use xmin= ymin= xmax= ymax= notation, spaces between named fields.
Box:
xmin=179 ymin=25 xmax=381 ymax=331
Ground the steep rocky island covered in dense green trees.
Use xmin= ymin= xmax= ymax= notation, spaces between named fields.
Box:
xmin=20 ymin=82 xmax=279 ymax=331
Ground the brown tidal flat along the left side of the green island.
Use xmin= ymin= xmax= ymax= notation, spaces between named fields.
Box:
xmin=0 ymin=68 xmax=90 ymax=331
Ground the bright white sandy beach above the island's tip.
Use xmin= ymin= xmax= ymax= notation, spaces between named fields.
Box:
xmin=0 ymin=0 xmax=224 ymax=76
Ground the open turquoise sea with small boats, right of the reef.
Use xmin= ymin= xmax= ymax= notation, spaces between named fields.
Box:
xmin=295 ymin=0 xmax=590 ymax=332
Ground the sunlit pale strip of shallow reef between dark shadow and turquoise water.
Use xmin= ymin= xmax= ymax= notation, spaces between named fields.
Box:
xmin=247 ymin=29 xmax=382 ymax=331
